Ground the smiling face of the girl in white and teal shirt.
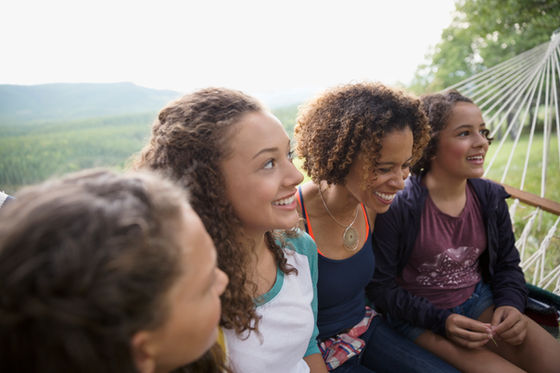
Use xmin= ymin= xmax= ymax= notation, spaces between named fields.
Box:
xmin=221 ymin=112 xmax=303 ymax=235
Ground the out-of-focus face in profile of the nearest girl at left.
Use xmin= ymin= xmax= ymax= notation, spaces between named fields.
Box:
xmin=136 ymin=207 xmax=228 ymax=373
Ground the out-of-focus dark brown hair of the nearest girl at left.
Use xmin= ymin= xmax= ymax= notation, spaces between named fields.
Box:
xmin=0 ymin=170 xmax=187 ymax=373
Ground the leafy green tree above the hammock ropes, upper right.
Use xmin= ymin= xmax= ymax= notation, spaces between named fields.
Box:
xmin=409 ymin=0 xmax=560 ymax=93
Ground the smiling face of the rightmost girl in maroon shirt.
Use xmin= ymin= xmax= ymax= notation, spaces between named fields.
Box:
xmin=430 ymin=102 xmax=488 ymax=179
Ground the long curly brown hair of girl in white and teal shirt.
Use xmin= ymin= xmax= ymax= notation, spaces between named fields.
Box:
xmin=135 ymin=88 xmax=294 ymax=334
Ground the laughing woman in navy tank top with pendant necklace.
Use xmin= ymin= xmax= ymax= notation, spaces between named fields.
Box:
xmin=295 ymin=83 xmax=456 ymax=372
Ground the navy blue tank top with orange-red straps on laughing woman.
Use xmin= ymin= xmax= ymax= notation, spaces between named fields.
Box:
xmin=298 ymin=187 xmax=375 ymax=340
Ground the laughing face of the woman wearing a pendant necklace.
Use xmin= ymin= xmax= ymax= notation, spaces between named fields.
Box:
xmin=345 ymin=127 xmax=413 ymax=214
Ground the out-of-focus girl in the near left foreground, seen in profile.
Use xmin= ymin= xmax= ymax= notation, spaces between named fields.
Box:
xmin=0 ymin=171 xmax=227 ymax=373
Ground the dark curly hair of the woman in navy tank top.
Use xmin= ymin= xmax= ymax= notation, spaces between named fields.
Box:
xmin=295 ymin=83 xmax=429 ymax=184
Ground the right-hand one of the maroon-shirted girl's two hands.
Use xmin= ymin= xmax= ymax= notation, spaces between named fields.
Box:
xmin=492 ymin=306 xmax=527 ymax=346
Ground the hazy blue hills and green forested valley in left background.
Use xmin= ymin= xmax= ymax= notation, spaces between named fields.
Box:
xmin=0 ymin=83 xmax=297 ymax=193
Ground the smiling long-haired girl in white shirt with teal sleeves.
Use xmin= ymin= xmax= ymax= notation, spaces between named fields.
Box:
xmin=137 ymin=88 xmax=326 ymax=373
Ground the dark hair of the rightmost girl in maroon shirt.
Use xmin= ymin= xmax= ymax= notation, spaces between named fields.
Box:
xmin=411 ymin=89 xmax=494 ymax=175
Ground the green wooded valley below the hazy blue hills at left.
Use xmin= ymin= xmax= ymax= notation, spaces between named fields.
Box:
xmin=0 ymin=113 xmax=154 ymax=193
